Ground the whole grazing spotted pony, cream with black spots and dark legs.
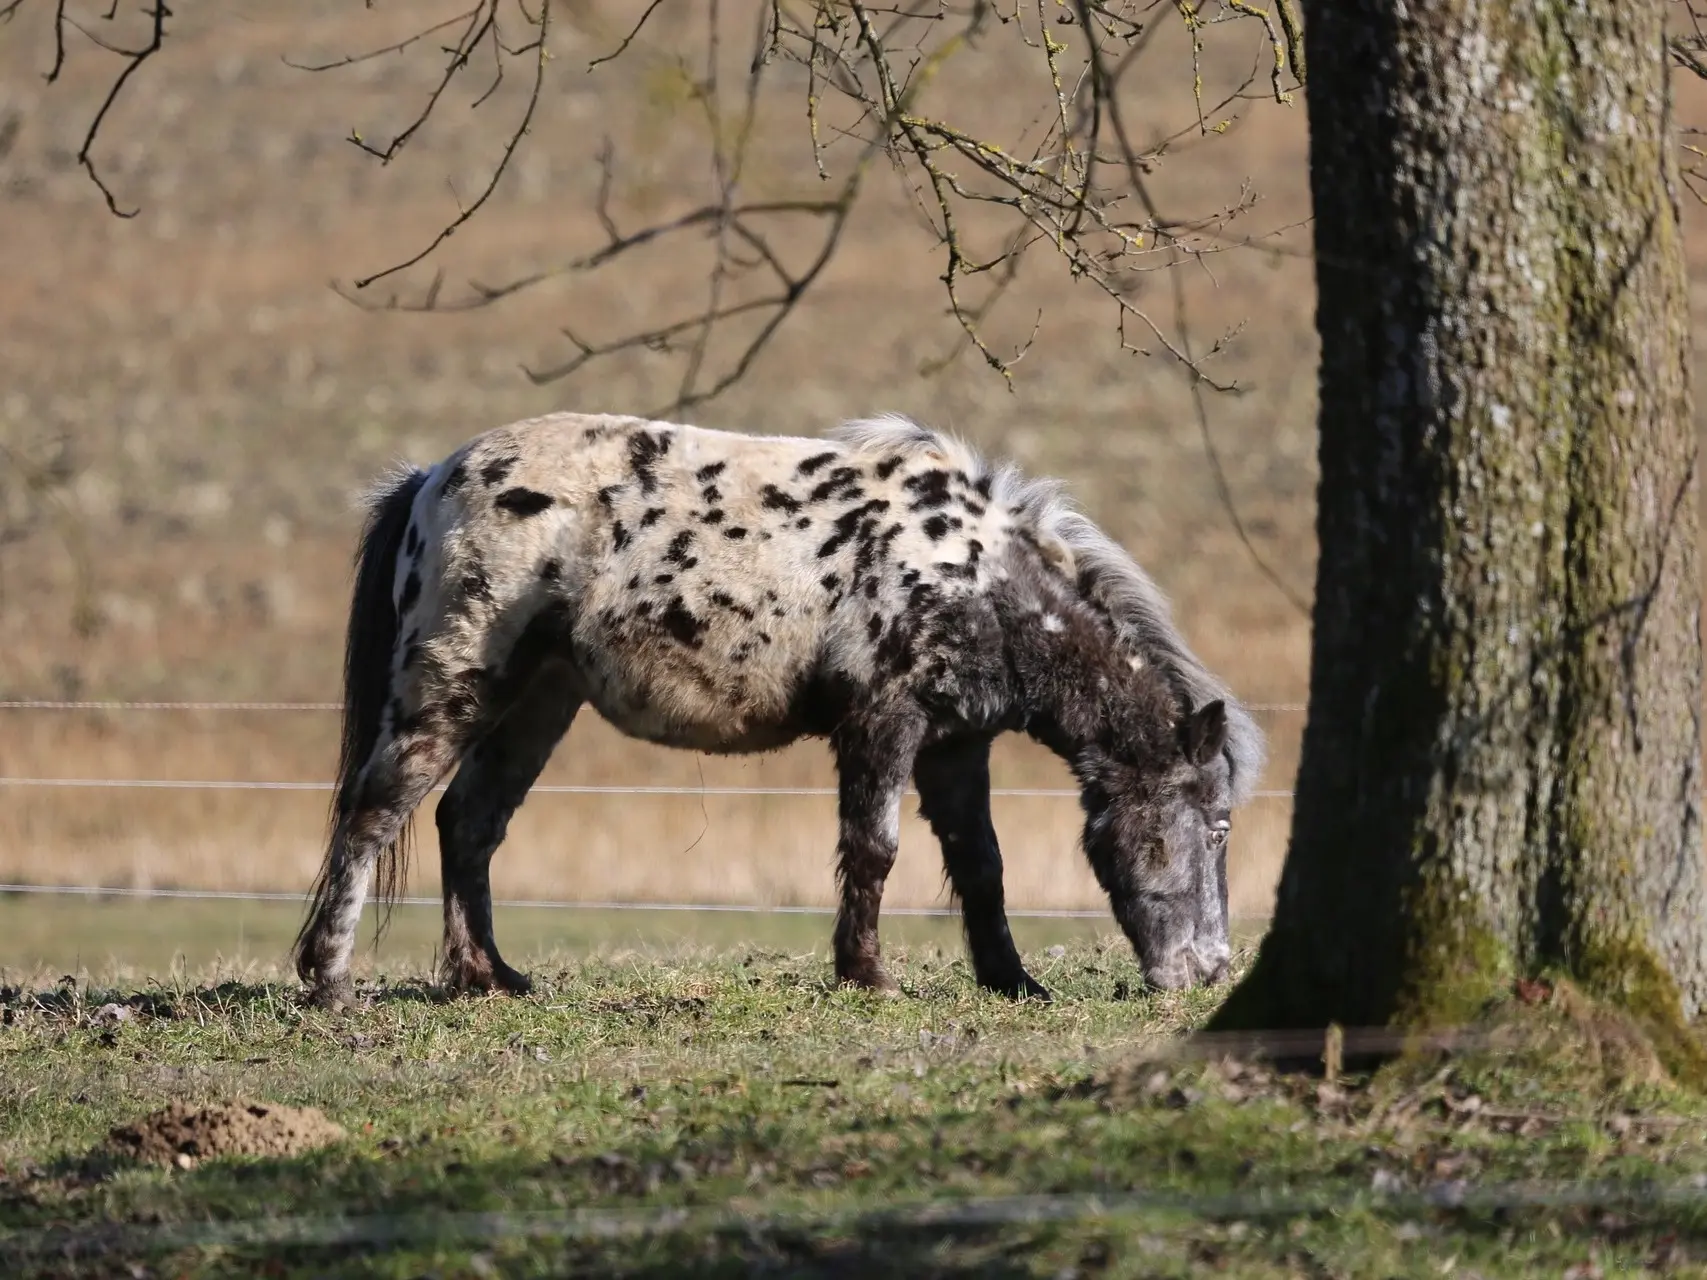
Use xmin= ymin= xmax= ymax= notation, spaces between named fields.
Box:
xmin=297 ymin=413 xmax=1263 ymax=1004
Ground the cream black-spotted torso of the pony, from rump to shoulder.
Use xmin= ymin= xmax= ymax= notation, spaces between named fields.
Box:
xmin=407 ymin=415 xmax=1051 ymax=751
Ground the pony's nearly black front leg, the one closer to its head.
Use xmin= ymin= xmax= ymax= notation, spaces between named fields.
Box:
xmin=913 ymin=737 xmax=1050 ymax=1000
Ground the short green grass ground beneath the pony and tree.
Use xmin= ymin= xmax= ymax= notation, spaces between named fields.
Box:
xmin=0 ymin=939 xmax=1707 ymax=1277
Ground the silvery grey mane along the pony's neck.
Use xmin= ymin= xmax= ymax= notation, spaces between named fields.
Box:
xmin=830 ymin=415 xmax=1267 ymax=804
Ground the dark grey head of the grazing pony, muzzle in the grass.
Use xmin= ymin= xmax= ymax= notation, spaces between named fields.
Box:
xmin=1079 ymin=701 xmax=1232 ymax=990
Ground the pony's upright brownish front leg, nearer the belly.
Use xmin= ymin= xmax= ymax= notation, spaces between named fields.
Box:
xmin=830 ymin=717 xmax=923 ymax=995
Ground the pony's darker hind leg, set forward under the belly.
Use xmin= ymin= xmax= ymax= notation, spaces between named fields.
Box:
xmin=437 ymin=669 xmax=580 ymax=995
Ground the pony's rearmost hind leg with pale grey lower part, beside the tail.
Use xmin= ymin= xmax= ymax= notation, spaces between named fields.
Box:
xmin=297 ymin=701 xmax=466 ymax=1005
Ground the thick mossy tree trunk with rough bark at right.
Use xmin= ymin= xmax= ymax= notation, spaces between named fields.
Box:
xmin=1217 ymin=0 xmax=1707 ymax=1031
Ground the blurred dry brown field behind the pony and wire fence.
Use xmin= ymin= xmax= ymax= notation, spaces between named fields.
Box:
xmin=0 ymin=2 xmax=1707 ymax=913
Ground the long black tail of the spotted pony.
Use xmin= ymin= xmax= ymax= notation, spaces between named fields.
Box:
xmin=295 ymin=466 xmax=430 ymax=956
